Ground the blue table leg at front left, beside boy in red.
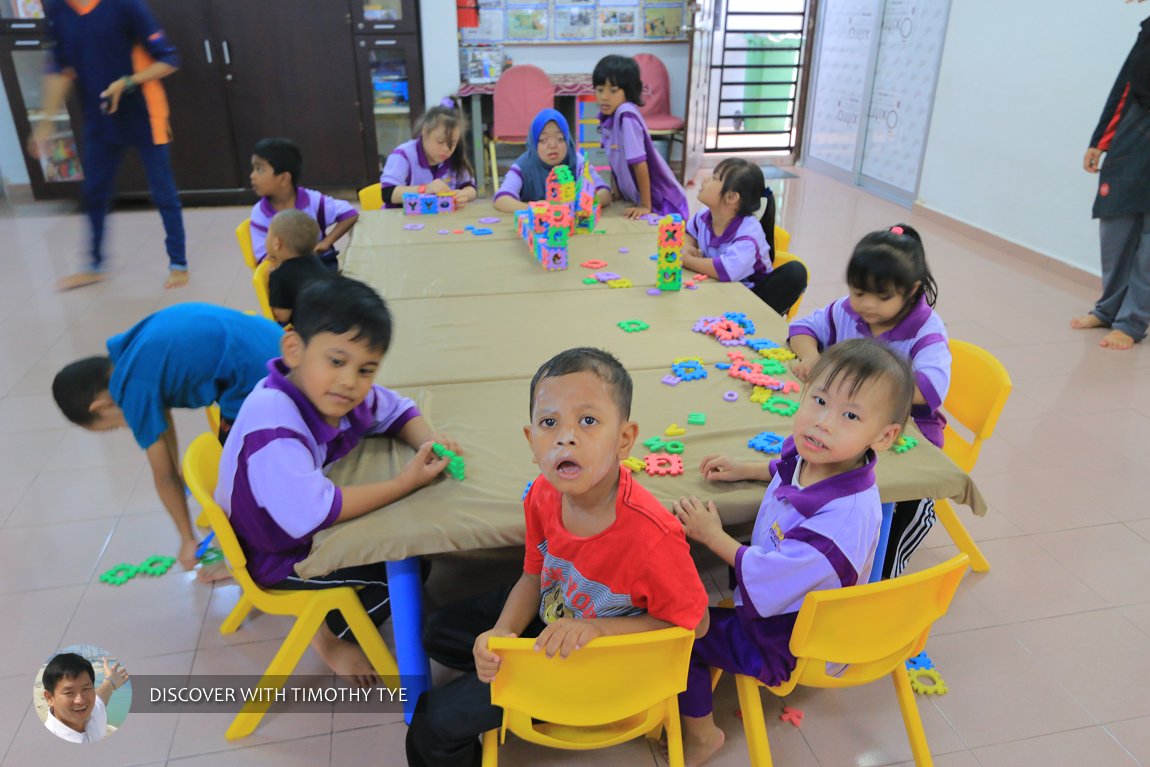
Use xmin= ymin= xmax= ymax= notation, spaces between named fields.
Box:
xmin=388 ymin=557 xmax=431 ymax=724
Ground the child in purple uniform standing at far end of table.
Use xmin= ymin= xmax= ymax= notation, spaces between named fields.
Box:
xmin=591 ymin=55 xmax=688 ymax=221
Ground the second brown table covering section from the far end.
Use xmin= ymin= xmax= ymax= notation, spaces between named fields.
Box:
xmin=344 ymin=228 xmax=667 ymax=301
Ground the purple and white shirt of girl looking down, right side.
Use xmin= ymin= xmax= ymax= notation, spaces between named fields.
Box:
xmin=789 ymin=297 xmax=951 ymax=447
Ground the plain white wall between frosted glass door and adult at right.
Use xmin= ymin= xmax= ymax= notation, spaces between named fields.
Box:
xmin=919 ymin=0 xmax=1147 ymax=274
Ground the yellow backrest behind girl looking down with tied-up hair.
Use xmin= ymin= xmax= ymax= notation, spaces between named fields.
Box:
xmin=942 ymin=338 xmax=1013 ymax=471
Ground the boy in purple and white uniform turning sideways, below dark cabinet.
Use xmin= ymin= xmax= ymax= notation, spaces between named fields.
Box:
xmin=251 ymin=138 xmax=359 ymax=271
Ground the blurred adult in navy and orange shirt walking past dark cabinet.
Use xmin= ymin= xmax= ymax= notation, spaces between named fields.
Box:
xmin=30 ymin=0 xmax=187 ymax=289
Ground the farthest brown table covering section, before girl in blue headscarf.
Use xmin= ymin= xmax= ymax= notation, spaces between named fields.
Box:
xmin=348 ymin=200 xmax=659 ymax=247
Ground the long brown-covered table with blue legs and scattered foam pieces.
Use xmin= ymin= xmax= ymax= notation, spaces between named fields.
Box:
xmin=322 ymin=204 xmax=986 ymax=719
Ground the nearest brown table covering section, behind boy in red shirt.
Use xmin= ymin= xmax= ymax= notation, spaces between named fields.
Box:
xmin=297 ymin=367 xmax=986 ymax=577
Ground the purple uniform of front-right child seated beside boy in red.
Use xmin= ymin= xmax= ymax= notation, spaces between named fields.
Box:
xmin=680 ymin=437 xmax=882 ymax=716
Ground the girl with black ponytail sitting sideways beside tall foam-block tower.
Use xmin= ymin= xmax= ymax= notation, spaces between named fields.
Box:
xmin=682 ymin=158 xmax=806 ymax=314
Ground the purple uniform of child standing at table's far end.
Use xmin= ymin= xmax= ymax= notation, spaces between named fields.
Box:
xmin=599 ymin=101 xmax=689 ymax=220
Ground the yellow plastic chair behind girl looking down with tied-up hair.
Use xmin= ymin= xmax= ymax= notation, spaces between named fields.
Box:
xmin=935 ymin=338 xmax=1013 ymax=573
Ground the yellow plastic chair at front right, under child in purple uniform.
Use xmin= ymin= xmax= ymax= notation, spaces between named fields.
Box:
xmin=714 ymin=554 xmax=969 ymax=767
